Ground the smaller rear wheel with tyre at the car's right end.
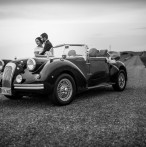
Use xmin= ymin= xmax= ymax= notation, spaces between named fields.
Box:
xmin=112 ymin=70 xmax=127 ymax=91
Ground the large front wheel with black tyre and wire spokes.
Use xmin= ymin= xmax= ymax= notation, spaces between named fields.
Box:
xmin=51 ymin=74 xmax=76 ymax=105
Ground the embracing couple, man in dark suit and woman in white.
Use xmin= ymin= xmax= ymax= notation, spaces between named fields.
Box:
xmin=34 ymin=33 xmax=53 ymax=56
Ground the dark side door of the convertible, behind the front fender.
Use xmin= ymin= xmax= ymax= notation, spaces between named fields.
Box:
xmin=88 ymin=57 xmax=109 ymax=87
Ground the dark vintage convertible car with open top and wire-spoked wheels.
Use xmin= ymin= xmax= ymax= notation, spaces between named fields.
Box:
xmin=0 ymin=44 xmax=127 ymax=105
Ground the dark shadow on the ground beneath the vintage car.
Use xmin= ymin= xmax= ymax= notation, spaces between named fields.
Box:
xmin=0 ymin=87 xmax=129 ymax=108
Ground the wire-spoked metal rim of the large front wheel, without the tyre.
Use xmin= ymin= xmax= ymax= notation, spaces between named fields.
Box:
xmin=57 ymin=78 xmax=73 ymax=101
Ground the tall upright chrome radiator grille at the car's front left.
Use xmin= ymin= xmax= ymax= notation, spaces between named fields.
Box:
xmin=2 ymin=63 xmax=16 ymax=88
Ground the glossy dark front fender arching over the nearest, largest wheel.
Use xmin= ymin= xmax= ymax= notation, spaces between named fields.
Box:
xmin=40 ymin=59 xmax=87 ymax=92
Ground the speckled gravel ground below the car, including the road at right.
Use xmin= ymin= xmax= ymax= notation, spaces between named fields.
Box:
xmin=0 ymin=56 xmax=146 ymax=147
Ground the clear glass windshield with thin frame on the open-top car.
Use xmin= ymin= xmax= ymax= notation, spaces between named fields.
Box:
xmin=53 ymin=45 xmax=86 ymax=58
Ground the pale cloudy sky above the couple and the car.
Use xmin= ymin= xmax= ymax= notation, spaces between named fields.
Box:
xmin=0 ymin=0 xmax=146 ymax=59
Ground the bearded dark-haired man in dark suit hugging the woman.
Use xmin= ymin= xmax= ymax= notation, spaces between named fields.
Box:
xmin=40 ymin=33 xmax=53 ymax=55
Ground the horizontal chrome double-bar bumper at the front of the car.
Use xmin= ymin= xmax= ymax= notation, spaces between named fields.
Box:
xmin=14 ymin=84 xmax=44 ymax=90
